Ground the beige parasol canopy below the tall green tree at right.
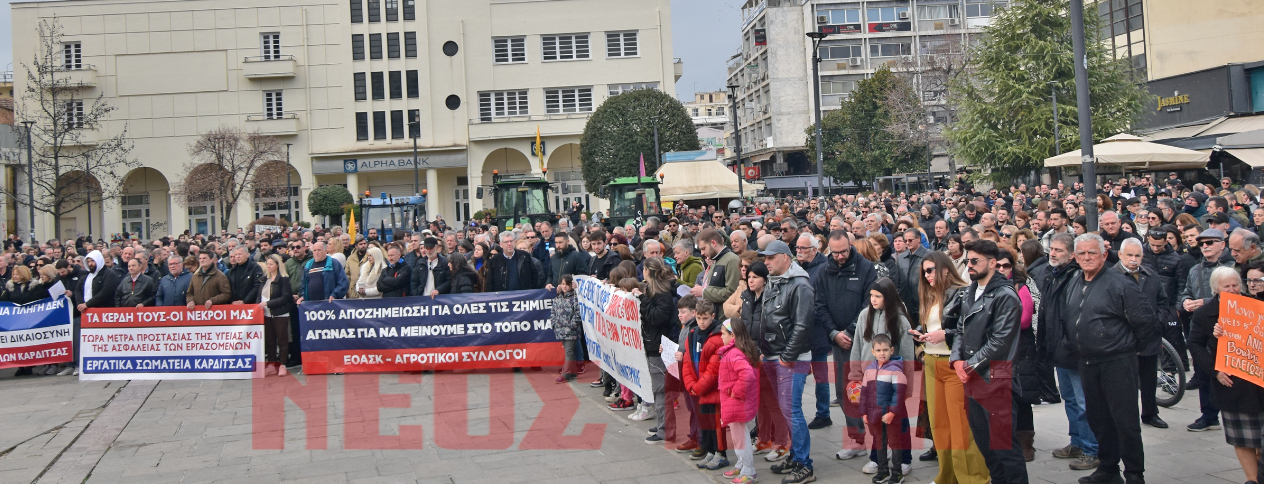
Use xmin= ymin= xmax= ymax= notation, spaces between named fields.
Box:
xmin=1044 ymin=133 xmax=1211 ymax=171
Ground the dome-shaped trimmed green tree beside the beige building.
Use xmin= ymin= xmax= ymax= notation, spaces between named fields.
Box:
xmin=579 ymin=88 xmax=702 ymax=193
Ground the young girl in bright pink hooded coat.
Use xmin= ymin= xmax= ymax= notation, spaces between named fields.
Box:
xmin=717 ymin=320 xmax=760 ymax=484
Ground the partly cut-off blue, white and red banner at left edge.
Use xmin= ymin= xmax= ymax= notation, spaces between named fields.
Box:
xmin=0 ymin=296 xmax=73 ymax=368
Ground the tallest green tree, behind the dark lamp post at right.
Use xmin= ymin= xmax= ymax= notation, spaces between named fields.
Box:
xmin=947 ymin=0 xmax=1150 ymax=182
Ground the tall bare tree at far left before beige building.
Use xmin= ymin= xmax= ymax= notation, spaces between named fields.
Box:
xmin=0 ymin=19 xmax=140 ymax=238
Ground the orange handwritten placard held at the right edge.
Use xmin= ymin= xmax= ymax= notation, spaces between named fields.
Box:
xmin=1216 ymin=293 xmax=1264 ymax=387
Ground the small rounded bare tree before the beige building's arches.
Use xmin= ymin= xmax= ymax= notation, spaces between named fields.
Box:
xmin=172 ymin=126 xmax=289 ymax=230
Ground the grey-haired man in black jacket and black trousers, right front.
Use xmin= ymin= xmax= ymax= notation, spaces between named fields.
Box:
xmin=1062 ymin=234 xmax=1158 ymax=484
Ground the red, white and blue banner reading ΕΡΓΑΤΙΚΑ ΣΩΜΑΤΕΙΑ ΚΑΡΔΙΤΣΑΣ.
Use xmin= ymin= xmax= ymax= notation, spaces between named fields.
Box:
xmin=80 ymin=305 xmax=263 ymax=380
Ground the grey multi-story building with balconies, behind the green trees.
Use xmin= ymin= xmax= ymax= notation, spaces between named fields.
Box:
xmin=728 ymin=0 xmax=1007 ymax=190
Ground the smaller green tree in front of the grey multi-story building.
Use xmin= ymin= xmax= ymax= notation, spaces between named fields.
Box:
xmin=806 ymin=66 xmax=927 ymax=185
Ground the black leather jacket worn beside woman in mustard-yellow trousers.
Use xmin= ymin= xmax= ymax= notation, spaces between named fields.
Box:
xmin=949 ymin=274 xmax=1023 ymax=380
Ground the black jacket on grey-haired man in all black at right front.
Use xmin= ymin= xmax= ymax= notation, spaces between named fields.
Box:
xmin=1050 ymin=267 xmax=1162 ymax=364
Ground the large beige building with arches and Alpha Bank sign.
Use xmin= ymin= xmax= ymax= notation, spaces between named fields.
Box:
xmin=13 ymin=0 xmax=683 ymax=239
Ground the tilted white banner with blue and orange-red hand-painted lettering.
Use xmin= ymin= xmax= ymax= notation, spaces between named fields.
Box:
xmin=575 ymin=275 xmax=653 ymax=403
